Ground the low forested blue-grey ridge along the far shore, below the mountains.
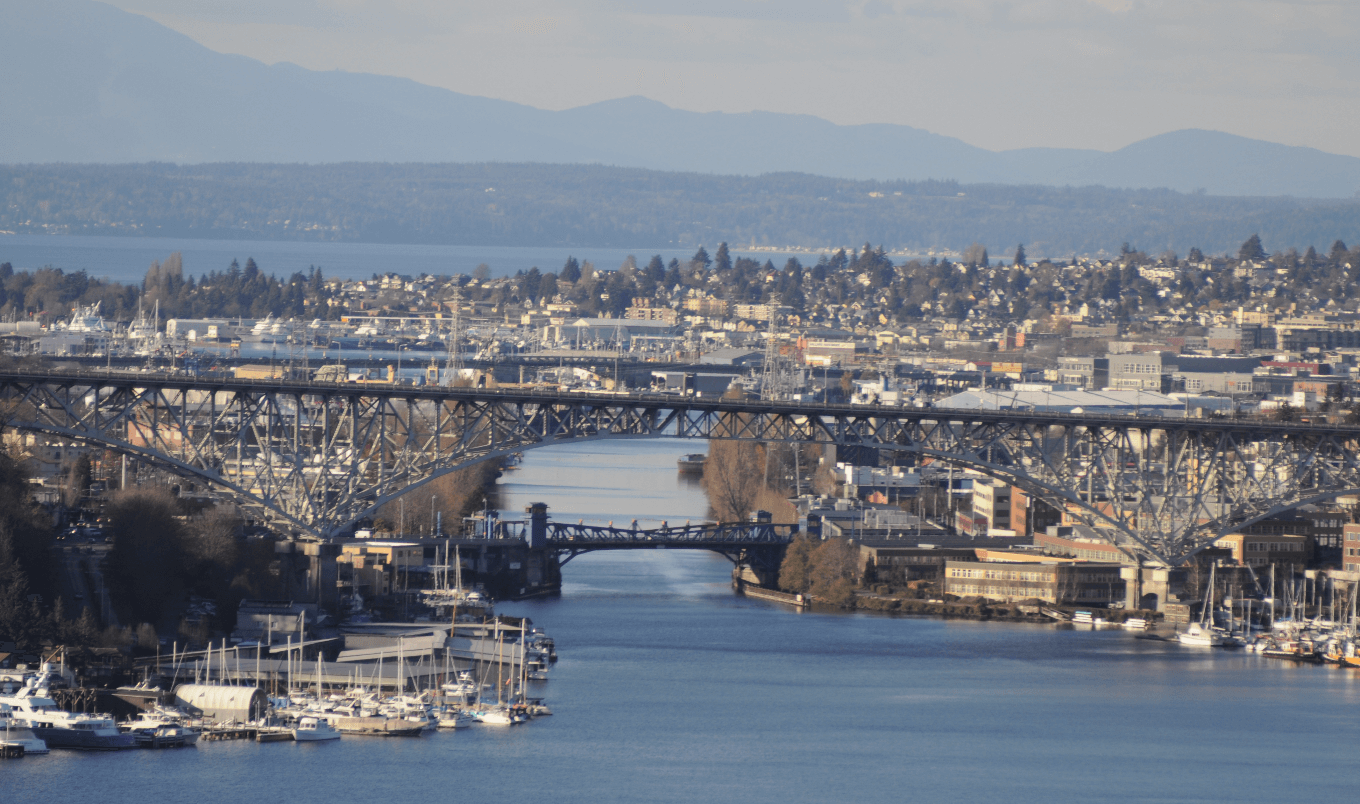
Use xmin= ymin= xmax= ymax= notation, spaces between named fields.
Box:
xmin=0 ymin=163 xmax=1360 ymax=254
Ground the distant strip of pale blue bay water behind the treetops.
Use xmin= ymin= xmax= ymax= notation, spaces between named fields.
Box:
xmin=0 ymin=234 xmax=816 ymax=283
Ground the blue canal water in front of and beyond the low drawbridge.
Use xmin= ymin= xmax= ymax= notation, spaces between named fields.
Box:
xmin=10 ymin=441 xmax=1360 ymax=804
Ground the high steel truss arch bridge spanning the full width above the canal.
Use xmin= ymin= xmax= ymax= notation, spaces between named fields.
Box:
xmin=0 ymin=370 xmax=1360 ymax=566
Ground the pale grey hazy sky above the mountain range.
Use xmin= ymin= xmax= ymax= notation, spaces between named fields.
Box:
xmin=113 ymin=0 xmax=1360 ymax=156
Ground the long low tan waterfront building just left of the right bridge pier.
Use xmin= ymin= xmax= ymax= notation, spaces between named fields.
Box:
xmin=944 ymin=559 xmax=1125 ymax=607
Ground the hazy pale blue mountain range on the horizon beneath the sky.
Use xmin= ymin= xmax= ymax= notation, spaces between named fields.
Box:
xmin=0 ymin=0 xmax=1360 ymax=199
